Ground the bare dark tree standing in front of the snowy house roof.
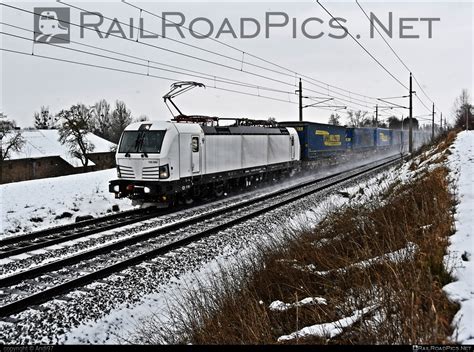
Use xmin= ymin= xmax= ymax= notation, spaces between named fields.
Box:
xmin=58 ymin=104 xmax=95 ymax=167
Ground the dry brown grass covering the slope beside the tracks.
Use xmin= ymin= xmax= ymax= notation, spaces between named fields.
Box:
xmin=135 ymin=134 xmax=457 ymax=344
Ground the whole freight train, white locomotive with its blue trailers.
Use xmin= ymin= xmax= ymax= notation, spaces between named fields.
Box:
xmin=109 ymin=116 xmax=429 ymax=204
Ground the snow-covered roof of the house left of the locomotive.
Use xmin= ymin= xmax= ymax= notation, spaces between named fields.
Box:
xmin=3 ymin=130 xmax=115 ymax=167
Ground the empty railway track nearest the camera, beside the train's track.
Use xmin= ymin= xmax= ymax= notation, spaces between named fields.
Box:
xmin=0 ymin=157 xmax=400 ymax=317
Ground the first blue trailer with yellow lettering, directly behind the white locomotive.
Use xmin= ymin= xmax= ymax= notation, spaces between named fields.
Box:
xmin=279 ymin=121 xmax=347 ymax=160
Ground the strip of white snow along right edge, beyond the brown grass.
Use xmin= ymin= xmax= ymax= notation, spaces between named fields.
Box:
xmin=444 ymin=131 xmax=474 ymax=344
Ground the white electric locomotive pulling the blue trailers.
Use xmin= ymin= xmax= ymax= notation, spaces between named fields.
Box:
xmin=109 ymin=117 xmax=300 ymax=203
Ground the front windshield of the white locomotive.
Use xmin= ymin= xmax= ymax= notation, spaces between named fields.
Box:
xmin=119 ymin=130 xmax=166 ymax=153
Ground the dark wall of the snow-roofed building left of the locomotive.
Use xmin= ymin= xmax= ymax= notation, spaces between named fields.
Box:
xmin=0 ymin=152 xmax=115 ymax=183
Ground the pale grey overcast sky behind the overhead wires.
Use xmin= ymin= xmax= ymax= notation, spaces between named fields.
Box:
xmin=0 ymin=1 xmax=474 ymax=127
